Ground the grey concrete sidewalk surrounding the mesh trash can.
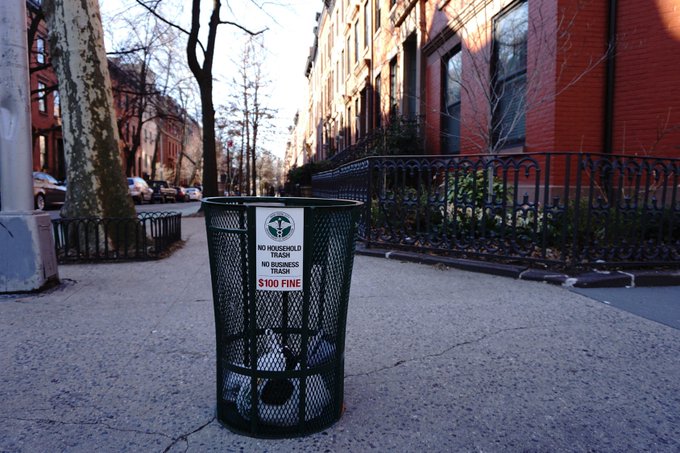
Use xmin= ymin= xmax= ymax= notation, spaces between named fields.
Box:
xmin=0 ymin=218 xmax=680 ymax=452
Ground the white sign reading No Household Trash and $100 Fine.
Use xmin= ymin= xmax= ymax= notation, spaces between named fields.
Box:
xmin=255 ymin=207 xmax=305 ymax=291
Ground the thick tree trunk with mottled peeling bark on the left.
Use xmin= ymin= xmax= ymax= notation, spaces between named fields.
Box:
xmin=43 ymin=0 xmax=136 ymax=218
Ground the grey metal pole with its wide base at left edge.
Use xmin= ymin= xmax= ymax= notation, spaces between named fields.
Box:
xmin=0 ymin=0 xmax=59 ymax=293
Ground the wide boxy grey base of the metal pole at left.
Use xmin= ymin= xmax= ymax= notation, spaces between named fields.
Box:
xmin=0 ymin=211 xmax=59 ymax=293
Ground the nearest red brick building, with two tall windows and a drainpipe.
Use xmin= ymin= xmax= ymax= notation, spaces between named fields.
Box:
xmin=423 ymin=0 xmax=680 ymax=156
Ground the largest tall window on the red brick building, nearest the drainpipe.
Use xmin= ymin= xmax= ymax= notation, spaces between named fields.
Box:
xmin=491 ymin=1 xmax=529 ymax=148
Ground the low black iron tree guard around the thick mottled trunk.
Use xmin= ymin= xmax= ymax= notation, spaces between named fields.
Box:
xmin=52 ymin=212 xmax=182 ymax=264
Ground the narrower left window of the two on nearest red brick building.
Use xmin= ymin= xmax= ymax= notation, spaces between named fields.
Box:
xmin=441 ymin=50 xmax=463 ymax=154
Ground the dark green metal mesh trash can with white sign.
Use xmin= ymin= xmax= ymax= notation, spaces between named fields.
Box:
xmin=203 ymin=197 xmax=361 ymax=437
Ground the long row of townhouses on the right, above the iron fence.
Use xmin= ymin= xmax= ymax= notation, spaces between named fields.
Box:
xmin=288 ymin=0 xmax=680 ymax=167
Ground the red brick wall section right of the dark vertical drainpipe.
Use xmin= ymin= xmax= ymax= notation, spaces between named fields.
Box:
xmin=613 ymin=0 xmax=680 ymax=157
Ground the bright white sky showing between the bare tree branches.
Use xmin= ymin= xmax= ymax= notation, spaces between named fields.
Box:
xmin=99 ymin=0 xmax=323 ymax=158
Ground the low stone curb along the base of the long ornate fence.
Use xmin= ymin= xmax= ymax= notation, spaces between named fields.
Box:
xmin=356 ymin=244 xmax=680 ymax=288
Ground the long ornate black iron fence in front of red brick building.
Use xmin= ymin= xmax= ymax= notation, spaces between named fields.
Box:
xmin=313 ymin=153 xmax=680 ymax=268
